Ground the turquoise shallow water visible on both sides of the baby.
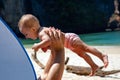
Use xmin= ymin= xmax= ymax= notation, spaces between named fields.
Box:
xmin=20 ymin=31 xmax=120 ymax=48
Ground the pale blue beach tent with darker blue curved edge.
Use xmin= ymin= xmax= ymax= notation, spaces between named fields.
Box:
xmin=0 ymin=18 xmax=37 ymax=80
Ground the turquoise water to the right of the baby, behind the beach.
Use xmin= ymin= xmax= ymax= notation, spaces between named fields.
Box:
xmin=79 ymin=31 xmax=120 ymax=46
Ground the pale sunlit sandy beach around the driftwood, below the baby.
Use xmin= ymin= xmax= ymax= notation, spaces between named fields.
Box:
xmin=26 ymin=46 xmax=120 ymax=80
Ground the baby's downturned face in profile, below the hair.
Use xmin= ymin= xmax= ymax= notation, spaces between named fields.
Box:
xmin=20 ymin=27 xmax=37 ymax=40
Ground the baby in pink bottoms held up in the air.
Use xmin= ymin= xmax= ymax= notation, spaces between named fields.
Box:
xmin=18 ymin=14 xmax=109 ymax=76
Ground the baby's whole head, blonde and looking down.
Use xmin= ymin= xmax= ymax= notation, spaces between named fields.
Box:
xmin=18 ymin=14 xmax=41 ymax=39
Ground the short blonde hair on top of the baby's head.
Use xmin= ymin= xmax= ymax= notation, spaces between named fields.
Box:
xmin=18 ymin=14 xmax=40 ymax=28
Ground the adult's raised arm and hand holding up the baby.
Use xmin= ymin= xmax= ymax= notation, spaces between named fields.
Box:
xmin=39 ymin=30 xmax=65 ymax=80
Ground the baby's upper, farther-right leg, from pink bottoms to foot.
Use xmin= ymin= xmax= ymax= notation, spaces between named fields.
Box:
xmin=72 ymin=39 xmax=109 ymax=67
